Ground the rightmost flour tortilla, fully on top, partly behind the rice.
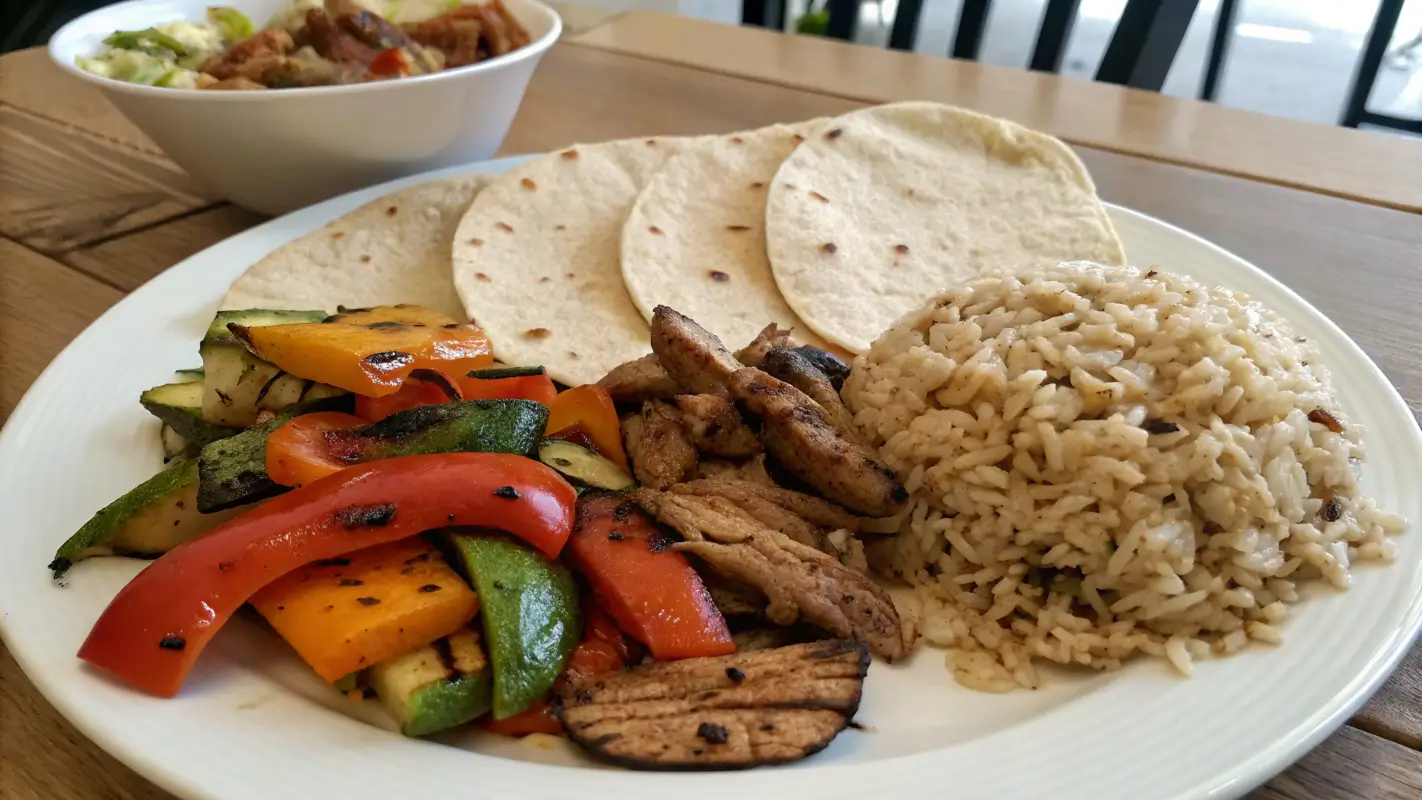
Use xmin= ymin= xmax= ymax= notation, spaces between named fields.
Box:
xmin=765 ymin=102 xmax=1125 ymax=352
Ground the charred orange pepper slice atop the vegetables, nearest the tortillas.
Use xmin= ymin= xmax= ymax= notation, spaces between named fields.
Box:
xmin=228 ymin=306 xmax=493 ymax=398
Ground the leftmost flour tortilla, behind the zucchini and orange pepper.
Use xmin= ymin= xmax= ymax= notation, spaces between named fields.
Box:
xmin=219 ymin=175 xmax=491 ymax=320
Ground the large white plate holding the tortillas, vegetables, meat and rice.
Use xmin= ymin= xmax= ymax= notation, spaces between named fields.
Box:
xmin=0 ymin=159 xmax=1422 ymax=800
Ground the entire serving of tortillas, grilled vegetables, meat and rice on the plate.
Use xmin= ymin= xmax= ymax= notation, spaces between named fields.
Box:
xmin=51 ymin=98 xmax=1405 ymax=769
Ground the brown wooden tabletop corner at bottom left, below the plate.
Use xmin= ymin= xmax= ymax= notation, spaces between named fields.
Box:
xmin=0 ymin=645 xmax=175 ymax=800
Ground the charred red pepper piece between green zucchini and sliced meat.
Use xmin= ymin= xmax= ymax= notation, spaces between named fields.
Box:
xmin=567 ymin=492 xmax=735 ymax=661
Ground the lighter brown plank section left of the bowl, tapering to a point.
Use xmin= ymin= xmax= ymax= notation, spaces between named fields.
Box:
xmin=0 ymin=105 xmax=213 ymax=253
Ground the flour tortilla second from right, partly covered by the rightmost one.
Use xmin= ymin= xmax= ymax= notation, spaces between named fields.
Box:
xmin=621 ymin=119 xmax=828 ymax=353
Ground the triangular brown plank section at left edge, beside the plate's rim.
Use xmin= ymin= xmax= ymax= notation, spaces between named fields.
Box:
xmin=0 ymin=239 xmax=124 ymax=425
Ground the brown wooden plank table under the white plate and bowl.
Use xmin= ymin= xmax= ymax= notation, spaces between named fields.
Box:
xmin=0 ymin=7 xmax=1422 ymax=800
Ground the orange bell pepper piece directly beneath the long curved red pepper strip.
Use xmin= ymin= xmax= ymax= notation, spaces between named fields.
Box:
xmin=252 ymin=537 xmax=479 ymax=682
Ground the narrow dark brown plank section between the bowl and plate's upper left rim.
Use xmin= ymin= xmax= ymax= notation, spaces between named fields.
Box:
xmin=58 ymin=203 xmax=266 ymax=291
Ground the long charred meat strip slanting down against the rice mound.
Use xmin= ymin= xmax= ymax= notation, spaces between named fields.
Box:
xmin=728 ymin=368 xmax=909 ymax=517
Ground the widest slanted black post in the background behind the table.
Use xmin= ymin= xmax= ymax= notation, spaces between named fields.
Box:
xmin=1096 ymin=0 xmax=1200 ymax=91
